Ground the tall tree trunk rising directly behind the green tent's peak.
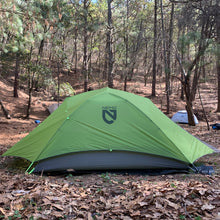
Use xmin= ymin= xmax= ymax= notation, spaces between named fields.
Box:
xmin=107 ymin=0 xmax=114 ymax=88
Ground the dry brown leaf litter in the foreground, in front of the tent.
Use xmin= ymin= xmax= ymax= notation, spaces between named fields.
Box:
xmin=0 ymin=164 xmax=220 ymax=220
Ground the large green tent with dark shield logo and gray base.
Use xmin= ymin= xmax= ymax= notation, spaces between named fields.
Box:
xmin=3 ymin=88 xmax=213 ymax=172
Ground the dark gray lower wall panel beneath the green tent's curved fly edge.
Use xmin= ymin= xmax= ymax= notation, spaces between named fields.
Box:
xmin=34 ymin=151 xmax=188 ymax=172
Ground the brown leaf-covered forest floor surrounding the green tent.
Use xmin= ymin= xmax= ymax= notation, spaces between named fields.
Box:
xmin=0 ymin=75 xmax=220 ymax=220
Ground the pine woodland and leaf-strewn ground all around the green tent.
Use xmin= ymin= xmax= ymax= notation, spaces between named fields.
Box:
xmin=0 ymin=0 xmax=220 ymax=219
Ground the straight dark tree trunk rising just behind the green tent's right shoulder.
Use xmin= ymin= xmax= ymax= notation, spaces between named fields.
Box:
xmin=151 ymin=0 xmax=157 ymax=96
